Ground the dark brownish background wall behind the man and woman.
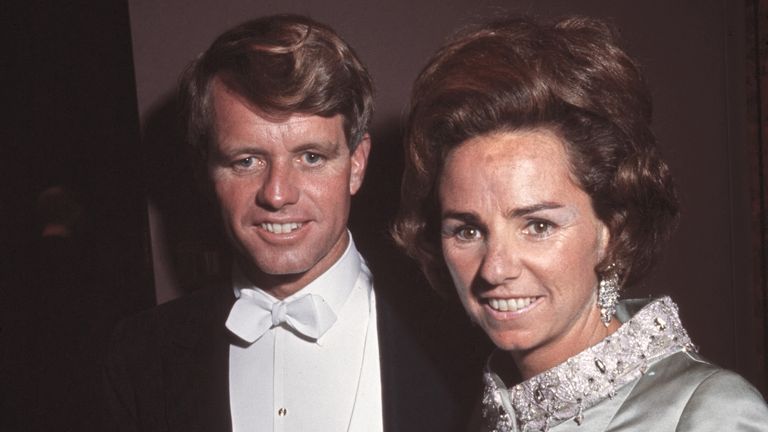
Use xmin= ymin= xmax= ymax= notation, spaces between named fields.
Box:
xmin=0 ymin=0 xmax=766 ymax=429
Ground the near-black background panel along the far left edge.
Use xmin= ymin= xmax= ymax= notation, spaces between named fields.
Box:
xmin=0 ymin=0 xmax=154 ymax=426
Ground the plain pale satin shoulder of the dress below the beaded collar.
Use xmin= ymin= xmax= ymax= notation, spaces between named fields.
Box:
xmin=550 ymin=352 xmax=768 ymax=432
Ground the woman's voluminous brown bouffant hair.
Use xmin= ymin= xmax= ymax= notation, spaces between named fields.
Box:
xmin=392 ymin=17 xmax=678 ymax=293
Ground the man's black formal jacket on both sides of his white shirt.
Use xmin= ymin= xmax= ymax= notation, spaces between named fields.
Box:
xmin=105 ymin=276 xmax=479 ymax=432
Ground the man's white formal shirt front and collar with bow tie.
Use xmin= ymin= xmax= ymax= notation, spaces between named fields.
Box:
xmin=227 ymin=235 xmax=383 ymax=432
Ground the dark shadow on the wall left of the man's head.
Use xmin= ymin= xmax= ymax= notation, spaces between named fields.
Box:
xmin=142 ymin=94 xmax=229 ymax=294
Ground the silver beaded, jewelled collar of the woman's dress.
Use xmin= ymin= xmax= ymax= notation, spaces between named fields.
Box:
xmin=482 ymin=297 xmax=696 ymax=432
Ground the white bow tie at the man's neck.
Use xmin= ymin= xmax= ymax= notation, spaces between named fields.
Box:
xmin=226 ymin=289 xmax=336 ymax=343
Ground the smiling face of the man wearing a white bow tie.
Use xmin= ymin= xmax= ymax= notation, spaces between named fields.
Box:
xmin=208 ymin=80 xmax=370 ymax=298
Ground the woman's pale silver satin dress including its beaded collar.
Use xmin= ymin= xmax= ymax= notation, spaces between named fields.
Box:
xmin=482 ymin=297 xmax=768 ymax=432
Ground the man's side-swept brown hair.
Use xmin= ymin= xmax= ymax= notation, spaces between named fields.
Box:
xmin=179 ymin=14 xmax=373 ymax=166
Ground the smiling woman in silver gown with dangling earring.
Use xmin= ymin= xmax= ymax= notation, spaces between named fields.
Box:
xmin=393 ymin=17 xmax=768 ymax=432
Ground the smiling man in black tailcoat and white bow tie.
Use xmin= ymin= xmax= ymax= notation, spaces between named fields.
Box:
xmin=106 ymin=15 xmax=476 ymax=432
